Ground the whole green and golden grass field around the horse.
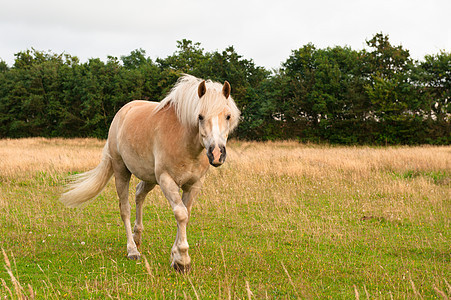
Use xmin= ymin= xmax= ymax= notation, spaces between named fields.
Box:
xmin=0 ymin=138 xmax=451 ymax=299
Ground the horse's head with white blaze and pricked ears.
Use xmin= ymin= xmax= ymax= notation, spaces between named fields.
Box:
xmin=198 ymin=81 xmax=239 ymax=167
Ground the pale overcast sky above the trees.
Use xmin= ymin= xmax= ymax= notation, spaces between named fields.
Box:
xmin=0 ymin=0 xmax=451 ymax=68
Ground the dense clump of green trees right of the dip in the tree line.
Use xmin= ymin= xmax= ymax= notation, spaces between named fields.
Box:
xmin=254 ymin=34 xmax=451 ymax=144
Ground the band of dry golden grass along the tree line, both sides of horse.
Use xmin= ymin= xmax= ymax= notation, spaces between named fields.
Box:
xmin=0 ymin=138 xmax=451 ymax=177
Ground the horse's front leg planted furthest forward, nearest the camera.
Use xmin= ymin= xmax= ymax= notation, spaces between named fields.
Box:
xmin=159 ymin=173 xmax=191 ymax=273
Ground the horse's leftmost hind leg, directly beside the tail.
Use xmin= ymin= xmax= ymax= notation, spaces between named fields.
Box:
xmin=113 ymin=160 xmax=141 ymax=260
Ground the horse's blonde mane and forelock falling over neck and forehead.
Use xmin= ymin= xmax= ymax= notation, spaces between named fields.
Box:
xmin=154 ymin=74 xmax=240 ymax=131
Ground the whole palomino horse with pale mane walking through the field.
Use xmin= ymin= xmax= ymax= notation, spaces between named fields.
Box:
xmin=61 ymin=75 xmax=244 ymax=272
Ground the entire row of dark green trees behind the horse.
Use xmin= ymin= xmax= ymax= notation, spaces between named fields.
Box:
xmin=0 ymin=33 xmax=451 ymax=144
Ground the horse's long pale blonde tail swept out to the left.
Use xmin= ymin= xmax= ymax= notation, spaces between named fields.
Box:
xmin=60 ymin=142 xmax=113 ymax=207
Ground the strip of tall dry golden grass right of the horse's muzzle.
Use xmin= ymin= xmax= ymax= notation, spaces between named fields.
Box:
xmin=229 ymin=142 xmax=451 ymax=177
